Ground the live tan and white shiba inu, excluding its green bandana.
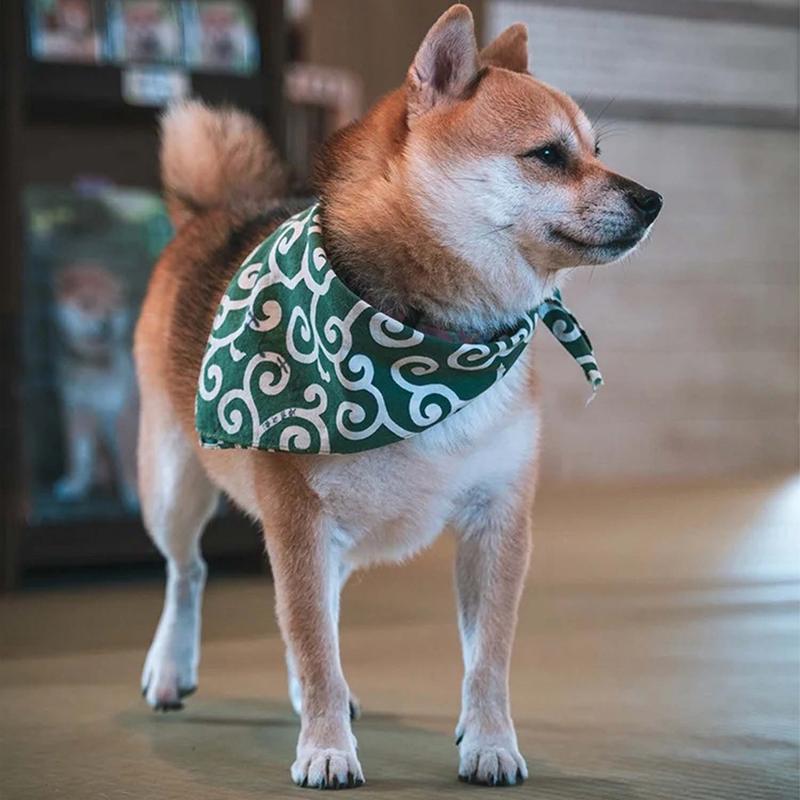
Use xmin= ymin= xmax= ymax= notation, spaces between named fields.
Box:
xmin=135 ymin=5 xmax=662 ymax=788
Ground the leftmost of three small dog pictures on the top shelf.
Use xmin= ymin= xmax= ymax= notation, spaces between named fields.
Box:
xmin=28 ymin=0 xmax=103 ymax=63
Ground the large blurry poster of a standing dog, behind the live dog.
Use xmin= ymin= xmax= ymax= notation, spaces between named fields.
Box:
xmin=23 ymin=185 xmax=171 ymax=521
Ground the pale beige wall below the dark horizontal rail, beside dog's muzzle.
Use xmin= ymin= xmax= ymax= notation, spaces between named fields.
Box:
xmin=537 ymin=121 xmax=800 ymax=479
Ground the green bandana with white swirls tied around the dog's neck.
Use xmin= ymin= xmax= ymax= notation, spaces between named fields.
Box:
xmin=195 ymin=205 xmax=603 ymax=453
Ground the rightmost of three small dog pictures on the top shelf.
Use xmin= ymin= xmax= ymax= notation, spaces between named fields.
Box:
xmin=183 ymin=0 xmax=259 ymax=75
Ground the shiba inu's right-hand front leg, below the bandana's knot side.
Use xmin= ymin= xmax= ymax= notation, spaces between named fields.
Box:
xmin=456 ymin=496 xmax=530 ymax=785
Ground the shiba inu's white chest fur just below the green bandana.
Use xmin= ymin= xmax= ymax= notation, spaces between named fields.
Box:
xmin=310 ymin=354 xmax=539 ymax=566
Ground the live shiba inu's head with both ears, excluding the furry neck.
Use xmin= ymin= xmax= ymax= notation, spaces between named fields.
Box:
xmin=407 ymin=6 xmax=661 ymax=271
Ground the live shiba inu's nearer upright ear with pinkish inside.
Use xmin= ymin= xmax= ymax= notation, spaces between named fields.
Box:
xmin=406 ymin=5 xmax=478 ymax=124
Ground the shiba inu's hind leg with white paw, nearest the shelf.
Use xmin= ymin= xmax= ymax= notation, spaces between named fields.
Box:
xmin=139 ymin=391 xmax=219 ymax=711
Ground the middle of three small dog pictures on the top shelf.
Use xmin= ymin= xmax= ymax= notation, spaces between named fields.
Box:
xmin=108 ymin=0 xmax=183 ymax=64
